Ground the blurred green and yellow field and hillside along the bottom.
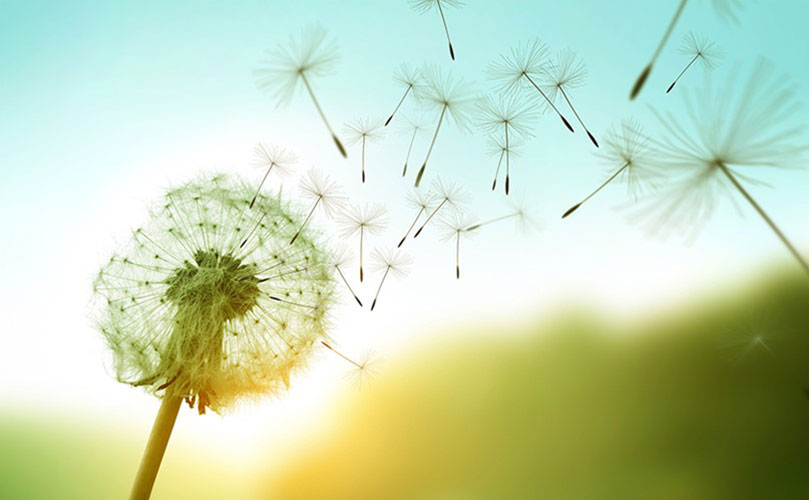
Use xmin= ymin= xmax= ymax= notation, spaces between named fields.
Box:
xmin=0 ymin=275 xmax=809 ymax=500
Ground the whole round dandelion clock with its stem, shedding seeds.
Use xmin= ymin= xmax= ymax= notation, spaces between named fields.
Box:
xmin=93 ymin=175 xmax=334 ymax=499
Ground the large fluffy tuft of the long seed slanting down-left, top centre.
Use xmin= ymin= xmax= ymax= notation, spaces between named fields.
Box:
xmin=420 ymin=65 xmax=474 ymax=130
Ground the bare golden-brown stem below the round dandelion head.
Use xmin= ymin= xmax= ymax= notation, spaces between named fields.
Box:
xmin=129 ymin=395 xmax=183 ymax=500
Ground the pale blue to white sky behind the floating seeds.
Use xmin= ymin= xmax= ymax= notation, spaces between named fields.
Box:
xmin=0 ymin=0 xmax=809 ymax=476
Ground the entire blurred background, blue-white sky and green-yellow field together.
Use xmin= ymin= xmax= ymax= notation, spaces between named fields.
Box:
xmin=0 ymin=0 xmax=809 ymax=499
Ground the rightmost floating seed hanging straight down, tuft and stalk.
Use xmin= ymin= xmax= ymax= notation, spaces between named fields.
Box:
xmin=478 ymin=95 xmax=537 ymax=195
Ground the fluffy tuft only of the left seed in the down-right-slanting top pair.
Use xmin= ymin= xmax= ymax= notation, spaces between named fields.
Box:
xmin=486 ymin=39 xmax=548 ymax=96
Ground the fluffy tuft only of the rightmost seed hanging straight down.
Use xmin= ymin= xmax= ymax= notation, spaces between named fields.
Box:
xmin=476 ymin=94 xmax=539 ymax=142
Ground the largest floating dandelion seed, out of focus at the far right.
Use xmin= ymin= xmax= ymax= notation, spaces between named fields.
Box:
xmin=638 ymin=60 xmax=809 ymax=273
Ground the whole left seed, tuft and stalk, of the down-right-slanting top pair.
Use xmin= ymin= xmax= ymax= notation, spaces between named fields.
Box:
xmin=487 ymin=39 xmax=573 ymax=132
